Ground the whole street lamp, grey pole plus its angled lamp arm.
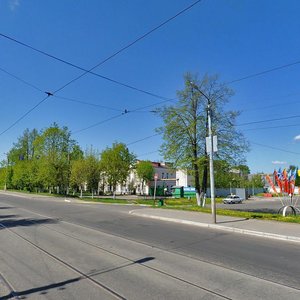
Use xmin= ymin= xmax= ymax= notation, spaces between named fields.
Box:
xmin=190 ymin=82 xmax=216 ymax=223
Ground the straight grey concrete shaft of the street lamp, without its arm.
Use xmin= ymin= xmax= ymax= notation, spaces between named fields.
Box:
xmin=207 ymin=101 xmax=217 ymax=223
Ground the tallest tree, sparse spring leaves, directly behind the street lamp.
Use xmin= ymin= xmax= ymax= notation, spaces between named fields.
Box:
xmin=157 ymin=73 xmax=248 ymax=204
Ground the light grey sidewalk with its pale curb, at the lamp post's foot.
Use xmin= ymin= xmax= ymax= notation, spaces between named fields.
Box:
xmin=129 ymin=208 xmax=300 ymax=243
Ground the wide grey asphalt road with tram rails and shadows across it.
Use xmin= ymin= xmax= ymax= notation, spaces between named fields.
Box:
xmin=0 ymin=194 xmax=300 ymax=299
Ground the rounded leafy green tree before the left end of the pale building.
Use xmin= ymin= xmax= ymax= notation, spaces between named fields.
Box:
xmin=100 ymin=143 xmax=135 ymax=194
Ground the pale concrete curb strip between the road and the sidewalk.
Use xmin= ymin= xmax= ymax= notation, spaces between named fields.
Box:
xmin=129 ymin=211 xmax=300 ymax=243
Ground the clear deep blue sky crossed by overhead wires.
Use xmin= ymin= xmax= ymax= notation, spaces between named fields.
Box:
xmin=0 ymin=0 xmax=300 ymax=172
